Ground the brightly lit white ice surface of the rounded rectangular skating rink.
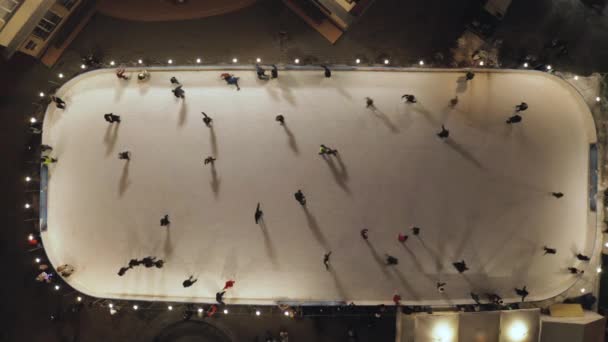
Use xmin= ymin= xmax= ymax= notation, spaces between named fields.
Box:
xmin=42 ymin=69 xmax=596 ymax=305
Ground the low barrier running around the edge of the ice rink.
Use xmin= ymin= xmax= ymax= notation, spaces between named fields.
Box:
xmin=40 ymin=67 xmax=601 ymax=307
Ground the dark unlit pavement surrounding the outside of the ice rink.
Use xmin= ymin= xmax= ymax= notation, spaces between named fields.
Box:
xmin=0 ymin=0 xmax=608 ymax=342
